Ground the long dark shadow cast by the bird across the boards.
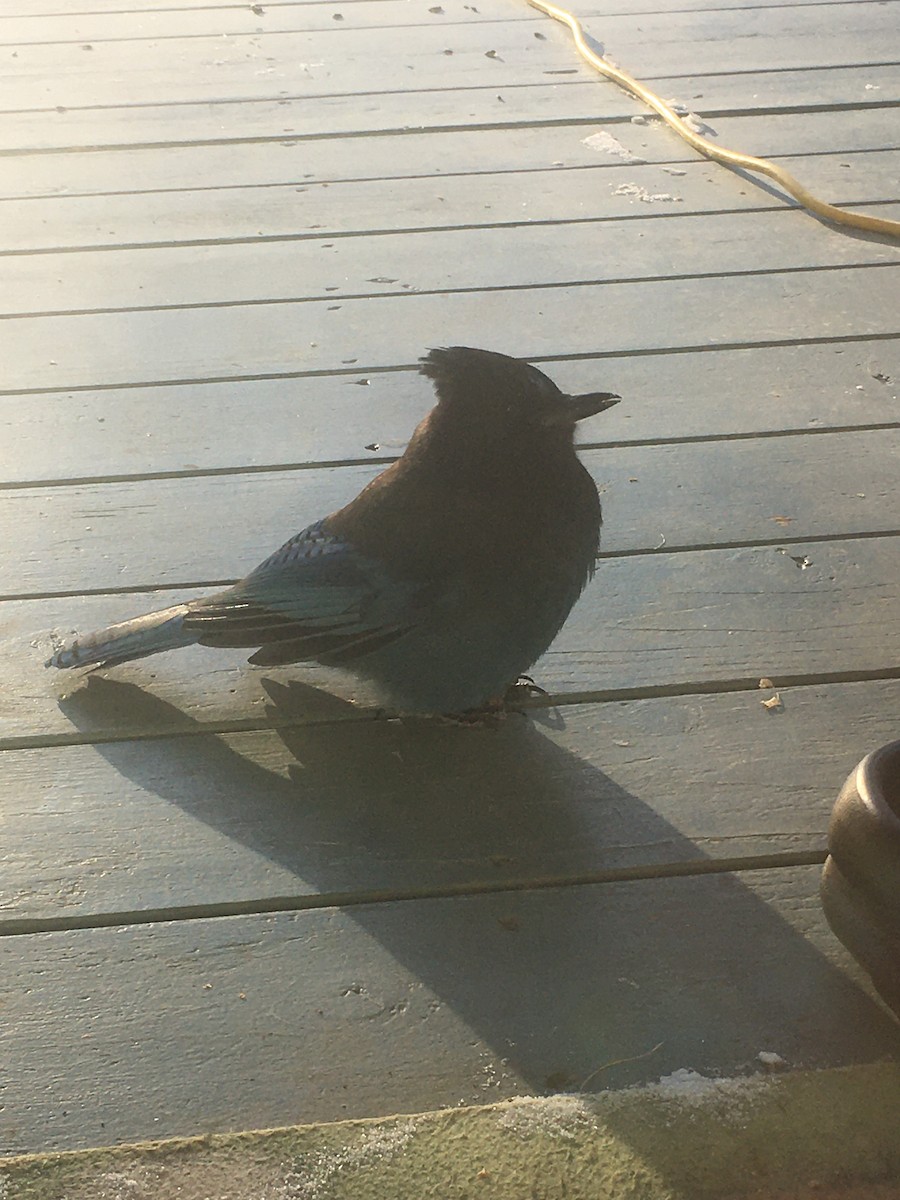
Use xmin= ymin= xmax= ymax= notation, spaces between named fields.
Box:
xmin=58 ymin=677 xmax=900 ymax=1108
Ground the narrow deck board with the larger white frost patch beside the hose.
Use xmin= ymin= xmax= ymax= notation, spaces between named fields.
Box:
xmin=0 ymin=109 xmax=898 ymax=201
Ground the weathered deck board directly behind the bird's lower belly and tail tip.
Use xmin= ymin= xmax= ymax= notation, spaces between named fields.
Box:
xmin=7 ymin=535 xmax=900 ymax=745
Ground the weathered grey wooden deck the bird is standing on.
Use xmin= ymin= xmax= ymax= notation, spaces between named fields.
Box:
xmin=0 ymin=0 xmax=900 ymax=1153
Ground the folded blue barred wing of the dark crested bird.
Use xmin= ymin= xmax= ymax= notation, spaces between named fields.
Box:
xmin=185 ymin=522 xmax=426 ymax=662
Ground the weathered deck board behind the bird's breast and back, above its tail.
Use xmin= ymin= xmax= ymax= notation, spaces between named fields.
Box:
xmin=0 ymin=432 xmax=900 ymax=596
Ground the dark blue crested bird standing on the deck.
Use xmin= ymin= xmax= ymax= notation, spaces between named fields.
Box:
xmin=48 ymin=346 xmax=618 ymax=713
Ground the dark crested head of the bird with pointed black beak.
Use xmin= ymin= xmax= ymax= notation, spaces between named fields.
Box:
xmin=421 ymin=346 xmax=619 ymax=444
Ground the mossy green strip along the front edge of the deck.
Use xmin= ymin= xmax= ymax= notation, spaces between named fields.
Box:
xmin=0 ymin=1063 xmax=900 ymax=1200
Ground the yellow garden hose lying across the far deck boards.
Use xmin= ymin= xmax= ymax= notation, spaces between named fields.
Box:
xmin=528 ymin=0 xmax=900 ymax=238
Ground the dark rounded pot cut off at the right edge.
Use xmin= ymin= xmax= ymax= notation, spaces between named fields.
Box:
xmin=822 ymin=742 xmax=900 ymax=1016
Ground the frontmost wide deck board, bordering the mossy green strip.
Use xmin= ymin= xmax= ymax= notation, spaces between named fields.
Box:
xmin=0 ymin=868 xmax=900 ymax=1152
